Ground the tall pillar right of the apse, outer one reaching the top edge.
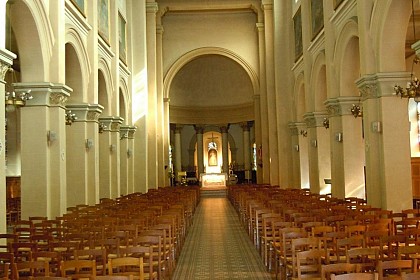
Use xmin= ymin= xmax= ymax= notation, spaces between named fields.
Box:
xmin=262 ymin=0 xmax=279 ymax=185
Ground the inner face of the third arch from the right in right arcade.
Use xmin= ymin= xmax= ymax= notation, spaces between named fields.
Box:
xmin=308 ymin=52 xmax=327 ymax=112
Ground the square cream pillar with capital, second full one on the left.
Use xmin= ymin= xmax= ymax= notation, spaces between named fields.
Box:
xmin=66 ymin=104 xmax=103 ymax=206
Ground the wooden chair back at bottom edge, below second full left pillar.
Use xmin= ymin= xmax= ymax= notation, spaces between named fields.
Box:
xmin=60 ymin=260 xmax=96 ymax=280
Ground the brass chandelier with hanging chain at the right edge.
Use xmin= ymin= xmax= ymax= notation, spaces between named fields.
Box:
xmin=394 ymin=0 xmax=420 ymax=100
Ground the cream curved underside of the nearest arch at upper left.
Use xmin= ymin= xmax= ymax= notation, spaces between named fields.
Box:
xmin=9 ymin=0 xmax=54 ymax=82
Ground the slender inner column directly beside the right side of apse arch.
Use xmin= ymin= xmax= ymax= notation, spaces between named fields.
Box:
xmin=257 ymin=23 xmax=270 ymax=184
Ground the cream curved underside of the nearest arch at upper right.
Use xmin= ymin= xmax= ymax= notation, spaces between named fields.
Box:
xmin=369 ymin=0 xmax=411 ymax=72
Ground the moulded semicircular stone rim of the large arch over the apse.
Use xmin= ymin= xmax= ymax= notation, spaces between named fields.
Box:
xmin=163 ymin=47 xmax=259 ymax=98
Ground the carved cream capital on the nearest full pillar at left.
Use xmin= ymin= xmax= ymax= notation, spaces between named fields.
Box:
xmin=14 ymin=83 xmax=73 ymax=108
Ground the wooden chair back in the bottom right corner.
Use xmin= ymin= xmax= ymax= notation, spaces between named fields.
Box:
xmin=376 ymin=259 xmax=417 ymax=280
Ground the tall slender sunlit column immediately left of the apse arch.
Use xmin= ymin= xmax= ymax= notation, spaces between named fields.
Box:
xmin=156 ymin=13 xmax=168 ymax=187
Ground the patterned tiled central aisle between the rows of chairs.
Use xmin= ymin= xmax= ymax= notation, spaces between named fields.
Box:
xmin=172 ymin=197 xmax=271 ymax=280
